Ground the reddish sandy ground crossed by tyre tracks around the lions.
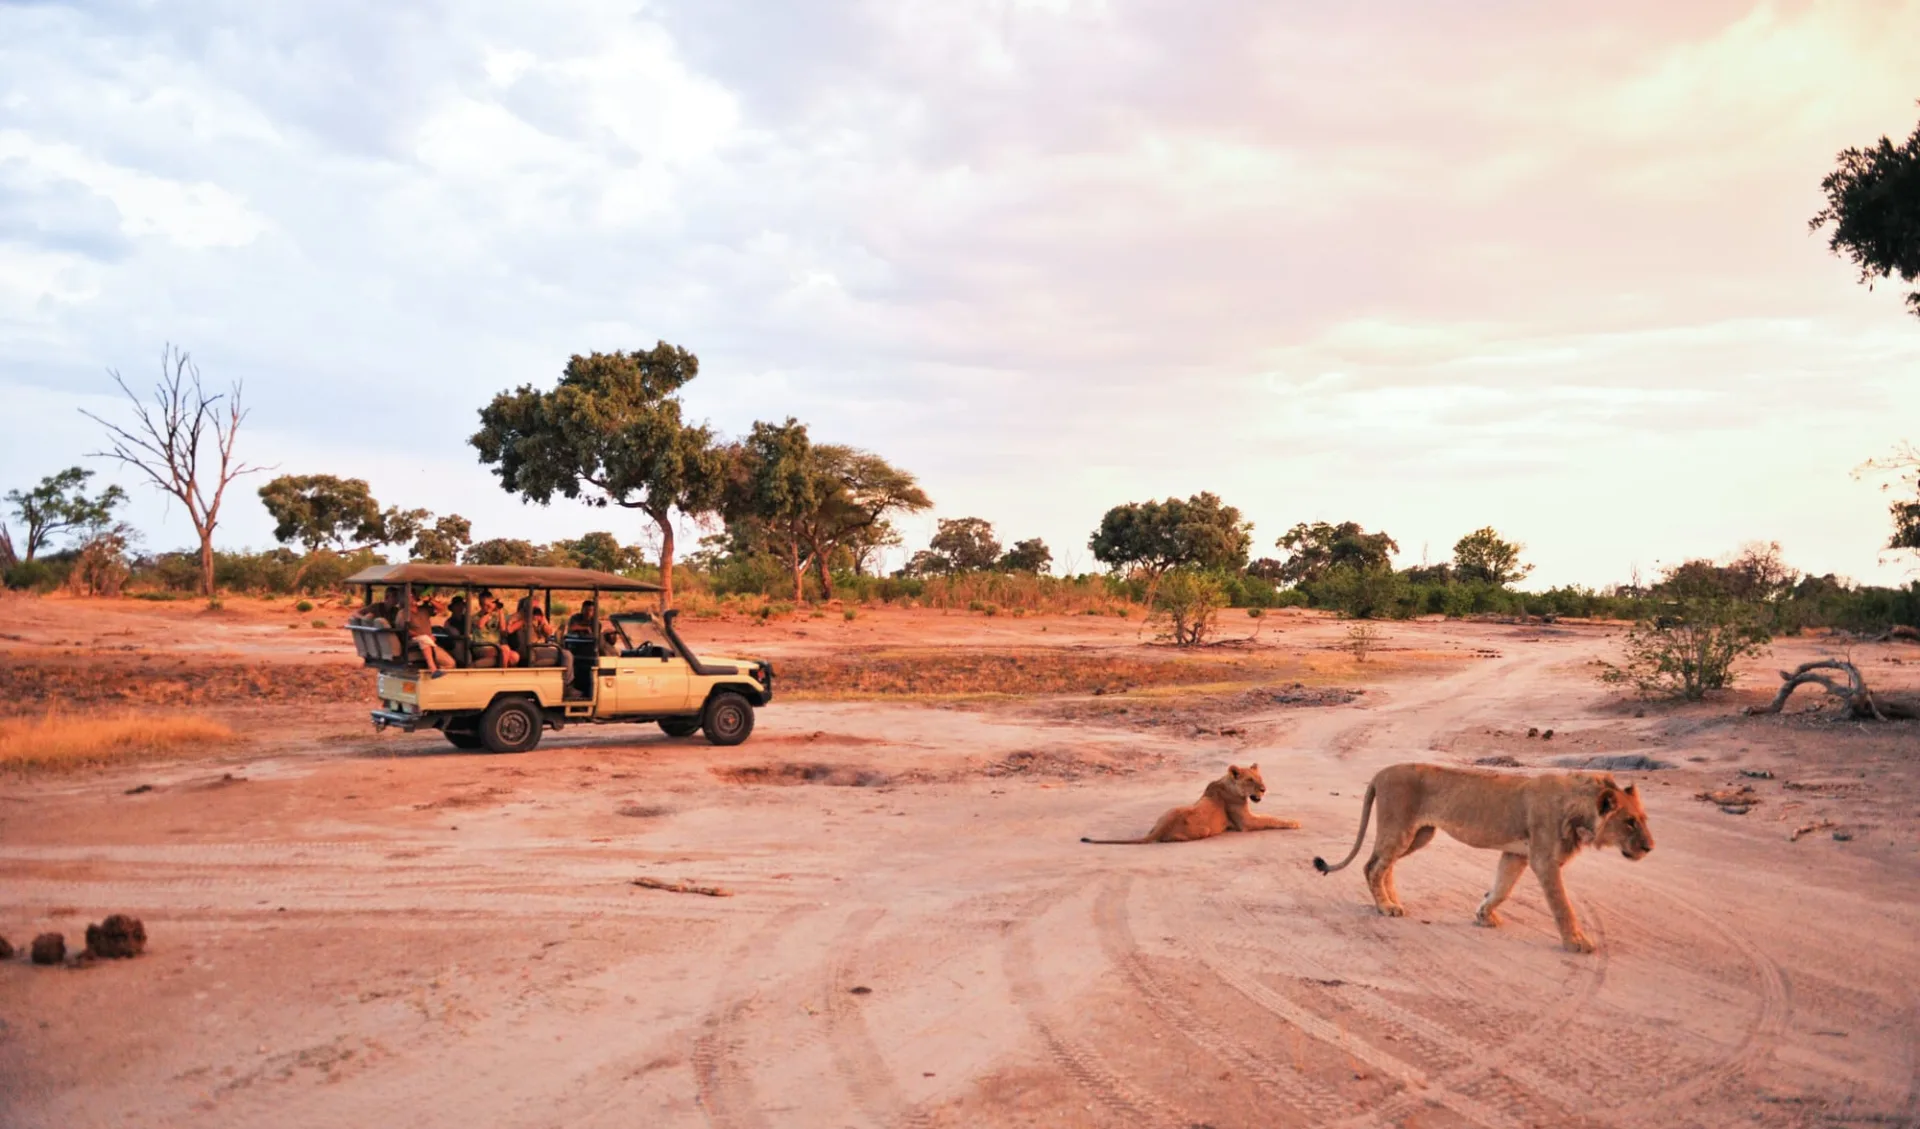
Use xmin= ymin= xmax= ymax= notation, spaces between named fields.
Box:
xmin=0 ymin=601 xmax=1920 ymax=1129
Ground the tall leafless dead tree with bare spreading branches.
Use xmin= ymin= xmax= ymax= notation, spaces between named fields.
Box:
xmin=81 ymin=344 xmax=261 ymax=607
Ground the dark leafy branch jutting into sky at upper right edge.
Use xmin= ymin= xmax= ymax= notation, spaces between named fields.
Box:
xmin=1809 ymin=110 xmax=1920 ymax=317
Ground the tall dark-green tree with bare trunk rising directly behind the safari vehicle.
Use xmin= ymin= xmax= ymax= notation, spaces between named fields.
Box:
xmin=468 ymin=342 xmax=726 ymax=607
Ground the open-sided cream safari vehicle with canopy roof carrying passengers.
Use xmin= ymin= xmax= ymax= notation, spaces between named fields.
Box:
xmin=346 ymin=563 xmax=774 ymax=753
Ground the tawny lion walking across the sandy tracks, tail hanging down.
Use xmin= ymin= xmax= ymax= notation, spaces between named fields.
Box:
xmin=1313 ymin=764 xmax=1653 ymax=952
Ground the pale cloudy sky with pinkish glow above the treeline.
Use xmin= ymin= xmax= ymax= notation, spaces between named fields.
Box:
xmin=0 ymin=0 xmax=1920 ymax=586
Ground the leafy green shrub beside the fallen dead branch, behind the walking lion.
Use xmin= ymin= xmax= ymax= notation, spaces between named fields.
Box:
xmin=1599 ymin=595 xmax=1768 ymax=701
